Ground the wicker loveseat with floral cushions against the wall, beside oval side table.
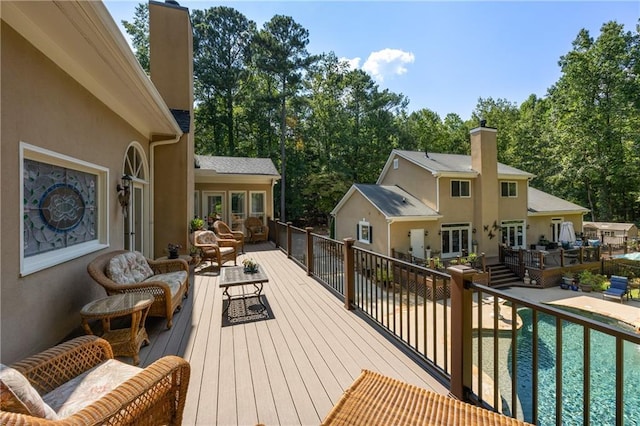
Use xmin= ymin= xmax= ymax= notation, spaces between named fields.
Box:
xmin=87 ymin=250 xmax=189 ymax=328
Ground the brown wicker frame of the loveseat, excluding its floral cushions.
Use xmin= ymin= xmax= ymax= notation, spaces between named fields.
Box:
xmin=87 ymin=250 xmax=189 ymax=328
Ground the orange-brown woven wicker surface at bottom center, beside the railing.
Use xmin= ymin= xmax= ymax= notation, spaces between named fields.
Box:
xmin=322 ymin=370 xmax=527 ymax=426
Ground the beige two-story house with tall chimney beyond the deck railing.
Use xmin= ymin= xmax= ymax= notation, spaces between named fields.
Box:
xmin=331 ymin=121 xmax=588 ymax=258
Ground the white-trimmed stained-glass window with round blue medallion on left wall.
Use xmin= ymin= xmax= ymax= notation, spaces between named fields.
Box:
xmin=20 ymin=142 xmax=109 ymax=276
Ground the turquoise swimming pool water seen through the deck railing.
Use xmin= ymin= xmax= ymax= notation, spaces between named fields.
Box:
xmin=509 ymin=308 xmax=640 ymax=425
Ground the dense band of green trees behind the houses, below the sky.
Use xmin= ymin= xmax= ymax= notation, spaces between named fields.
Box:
xmin=123 ymin=4 xmax=640 ymax=225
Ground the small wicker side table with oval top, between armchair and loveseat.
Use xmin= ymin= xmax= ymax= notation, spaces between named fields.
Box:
xmin=80 ymin=293 xmax=153 ymax=365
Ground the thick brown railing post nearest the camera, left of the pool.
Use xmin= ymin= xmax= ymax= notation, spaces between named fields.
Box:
xmin=447 ymin=265 xmax=474 ymax=401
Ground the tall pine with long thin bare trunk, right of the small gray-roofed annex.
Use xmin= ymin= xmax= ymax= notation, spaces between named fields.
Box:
xmin=253 ymin=15 xmax=315 ymax=221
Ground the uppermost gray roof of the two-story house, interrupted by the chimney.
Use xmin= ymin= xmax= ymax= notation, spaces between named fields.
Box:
xmin=394 ymin=149 xmax=533 ymax=177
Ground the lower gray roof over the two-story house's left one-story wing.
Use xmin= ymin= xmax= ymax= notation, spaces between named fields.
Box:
xmin=354 ymin=184 xmax=439 ymax=217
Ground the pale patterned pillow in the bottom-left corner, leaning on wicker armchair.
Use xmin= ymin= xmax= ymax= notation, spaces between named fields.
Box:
xmin=0 ymin=364 xmax=58 ymax=420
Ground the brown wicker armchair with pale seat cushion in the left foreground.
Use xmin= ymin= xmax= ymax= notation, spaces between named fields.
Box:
xmin=0 ymin=336 xmax=191 ymax=425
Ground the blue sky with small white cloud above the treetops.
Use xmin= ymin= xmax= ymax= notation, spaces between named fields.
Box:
xmin=105 ymin=0 xmax=640 ymax=120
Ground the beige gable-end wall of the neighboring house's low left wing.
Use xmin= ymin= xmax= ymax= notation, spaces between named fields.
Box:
xmin=336 ymin=191 xmax=388 ymax=255
